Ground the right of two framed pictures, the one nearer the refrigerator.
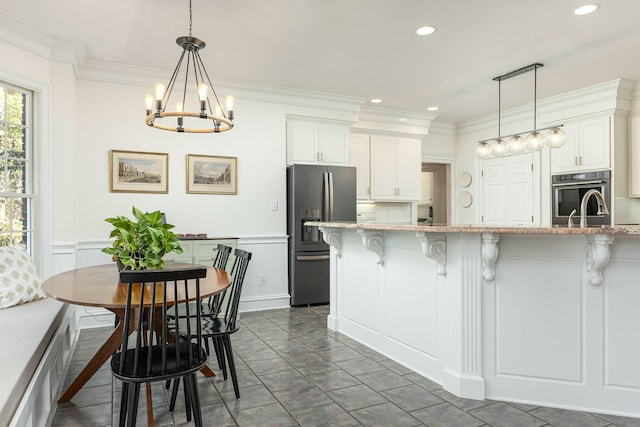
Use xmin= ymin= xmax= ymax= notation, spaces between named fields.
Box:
xmin=187 ymin=154 xmax=238 ymax=194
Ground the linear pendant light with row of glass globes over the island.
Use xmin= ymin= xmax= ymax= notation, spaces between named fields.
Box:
xmin=476 ymin=63 xmax=567 ymax=159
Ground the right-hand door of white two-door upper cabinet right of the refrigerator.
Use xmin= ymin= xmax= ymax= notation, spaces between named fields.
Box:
xmin=396 ymin=138 xmax=422 ymax=201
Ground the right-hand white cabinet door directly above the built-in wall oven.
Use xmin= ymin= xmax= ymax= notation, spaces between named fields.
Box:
xmin=580 ymin=116 xmax=611 ymax=170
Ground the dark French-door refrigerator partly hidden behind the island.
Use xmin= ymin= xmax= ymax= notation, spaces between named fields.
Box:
xmin=287 ymin=165 xmax=356 ymax=306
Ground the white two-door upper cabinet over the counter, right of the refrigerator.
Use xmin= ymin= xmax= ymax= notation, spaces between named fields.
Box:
xmin=370 ymin=135 xmax=422 ymax=201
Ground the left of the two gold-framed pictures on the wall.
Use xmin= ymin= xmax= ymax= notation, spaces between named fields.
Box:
xmin=109 ymin=150 xmax=169 ymax=194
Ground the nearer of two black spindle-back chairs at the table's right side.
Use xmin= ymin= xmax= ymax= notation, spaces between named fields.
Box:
xmin=169 ymin=249 xmax=251 ymax=411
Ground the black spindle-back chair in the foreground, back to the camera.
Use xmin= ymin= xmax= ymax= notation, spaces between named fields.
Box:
xmin=111 ymin=267 xmax=207 ymax=426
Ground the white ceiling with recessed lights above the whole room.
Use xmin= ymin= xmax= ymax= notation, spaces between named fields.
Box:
xmin=0 ymin=0 xmax=640 ymax=123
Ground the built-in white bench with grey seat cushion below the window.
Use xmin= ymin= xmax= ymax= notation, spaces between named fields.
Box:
xmin=0 ymin=298 xmax=76 ymax=427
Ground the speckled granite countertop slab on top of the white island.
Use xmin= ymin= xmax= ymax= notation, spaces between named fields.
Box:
xmin=305 ymin=222 xmax=640 ymax=235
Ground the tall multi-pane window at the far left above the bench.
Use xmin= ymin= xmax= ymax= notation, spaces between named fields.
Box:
xmin=0 ymin=82 xmax=33 ymax=252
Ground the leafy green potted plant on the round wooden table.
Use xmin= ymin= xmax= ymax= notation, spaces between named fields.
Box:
xmin=102 ymin=206 xmax=182 ymax=270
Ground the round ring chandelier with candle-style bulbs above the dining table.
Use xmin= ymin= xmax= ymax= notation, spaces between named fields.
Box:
xmin=145 ymin=0 xmax=234 ymax=133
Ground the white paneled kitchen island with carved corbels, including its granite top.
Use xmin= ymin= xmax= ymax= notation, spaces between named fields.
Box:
xmin=310 ymin=223 xmax=640 ymax=417
